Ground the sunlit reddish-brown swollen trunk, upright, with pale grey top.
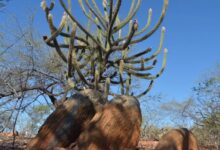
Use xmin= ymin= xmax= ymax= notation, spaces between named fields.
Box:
xmin=71 ymin=96 xmax=141 ymax=150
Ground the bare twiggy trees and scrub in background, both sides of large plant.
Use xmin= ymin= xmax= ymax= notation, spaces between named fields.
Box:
xmin=0 ymin=1 xmax=220 ymax=149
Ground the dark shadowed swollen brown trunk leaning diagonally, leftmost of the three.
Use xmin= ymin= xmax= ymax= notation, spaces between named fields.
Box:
xmin=28 ymin=90 xmax=103 ymax=150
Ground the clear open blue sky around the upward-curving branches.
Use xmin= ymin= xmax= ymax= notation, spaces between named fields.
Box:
xmin=0 ymin=0 xmax=220 ymax=103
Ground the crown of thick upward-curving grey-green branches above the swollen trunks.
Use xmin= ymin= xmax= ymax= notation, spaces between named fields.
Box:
xmin=41 ymin=0 xmax=168 ymax=98
